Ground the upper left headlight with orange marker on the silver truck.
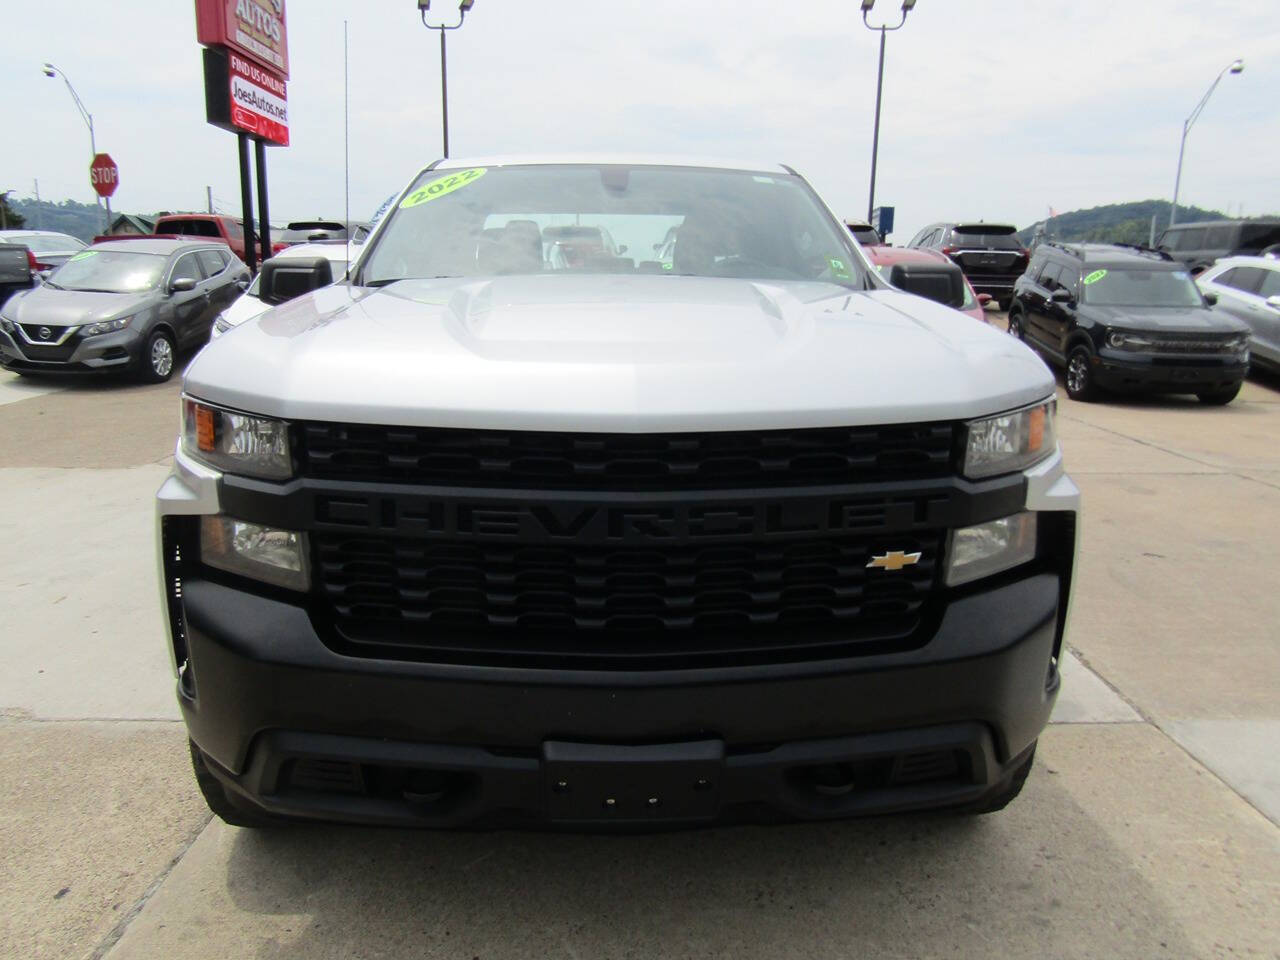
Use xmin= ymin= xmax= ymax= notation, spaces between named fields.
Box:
xmin=182 ymin=397 xmax=293 ymax=480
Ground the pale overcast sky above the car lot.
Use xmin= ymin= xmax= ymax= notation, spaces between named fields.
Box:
xmin=0 ymin=0 xmax=1280 ymax=243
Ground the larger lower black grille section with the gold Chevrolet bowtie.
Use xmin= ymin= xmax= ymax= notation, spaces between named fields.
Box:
xmin=312 ymin=531 xmax=942 ymax=666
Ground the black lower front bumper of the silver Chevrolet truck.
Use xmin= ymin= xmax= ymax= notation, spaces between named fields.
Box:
xmin=179 ymin=572 xmax=1062 ymax=827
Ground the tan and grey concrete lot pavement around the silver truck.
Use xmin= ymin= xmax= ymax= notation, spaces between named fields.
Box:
xmin=0 ymin=320 xmax=1280 ymax=960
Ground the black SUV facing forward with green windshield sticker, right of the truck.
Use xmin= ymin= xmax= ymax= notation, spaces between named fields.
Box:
xmin=1009 ymin=242 xmax=1249 ymax=404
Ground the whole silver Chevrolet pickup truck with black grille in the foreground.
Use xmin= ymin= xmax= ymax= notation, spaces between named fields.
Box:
xmin=159 ymin=157 xmax=1079 ymax=828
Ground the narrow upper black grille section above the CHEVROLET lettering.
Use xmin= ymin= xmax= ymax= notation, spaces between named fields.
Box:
xmin=297 ymin=422 xmax=955 ymax=492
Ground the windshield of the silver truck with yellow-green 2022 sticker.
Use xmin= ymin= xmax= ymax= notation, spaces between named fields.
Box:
xmin=360 ymin=164 xmax=865 ymax=287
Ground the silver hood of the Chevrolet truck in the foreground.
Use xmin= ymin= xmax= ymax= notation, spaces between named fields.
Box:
xmin=186 ymin=275 xmax=1053 ymax=433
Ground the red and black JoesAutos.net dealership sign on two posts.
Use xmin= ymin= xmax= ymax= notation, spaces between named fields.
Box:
xmin=196 ymin=0 xmax=289 ymax=269
